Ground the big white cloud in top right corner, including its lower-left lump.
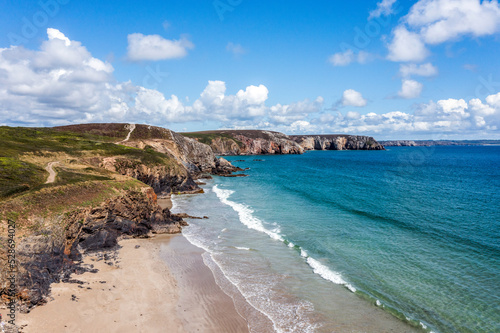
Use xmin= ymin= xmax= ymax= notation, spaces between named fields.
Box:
xmin=388 ymin=0 xmax=500 ymax=62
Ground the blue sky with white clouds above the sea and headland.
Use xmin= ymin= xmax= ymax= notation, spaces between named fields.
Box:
xmin=0 ymin=0 xmax=500 ymax=140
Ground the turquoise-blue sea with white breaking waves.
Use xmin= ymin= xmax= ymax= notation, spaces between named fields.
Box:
xmin=173 ymin=146 xmax=500 ymax=333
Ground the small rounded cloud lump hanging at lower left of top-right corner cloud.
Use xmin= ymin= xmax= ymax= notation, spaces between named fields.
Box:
xmin=387 ymin=26 xmax=429 ymax=62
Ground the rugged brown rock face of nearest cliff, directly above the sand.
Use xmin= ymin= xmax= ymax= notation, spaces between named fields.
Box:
xmin=0 ymin=188 xmax=186 ymax=311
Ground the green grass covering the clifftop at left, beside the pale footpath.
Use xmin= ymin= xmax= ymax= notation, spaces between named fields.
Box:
xmin=0 ymin=126 xmax=176 ymax=200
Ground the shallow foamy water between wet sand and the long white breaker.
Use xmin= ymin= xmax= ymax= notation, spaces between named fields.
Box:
xmin=175 ymin=180 xmax=425 ymax=333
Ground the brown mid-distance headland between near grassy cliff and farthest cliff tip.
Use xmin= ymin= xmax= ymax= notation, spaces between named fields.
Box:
xmin=182 ymin=130 xmax=303 ymax=155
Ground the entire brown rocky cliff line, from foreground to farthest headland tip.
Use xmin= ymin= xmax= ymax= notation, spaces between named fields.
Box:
xmin=0 ymin=124 xmax=384 ymax=310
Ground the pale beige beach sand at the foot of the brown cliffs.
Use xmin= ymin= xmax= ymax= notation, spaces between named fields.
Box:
xmin=16 ymin=235 xmax=248 ymax=333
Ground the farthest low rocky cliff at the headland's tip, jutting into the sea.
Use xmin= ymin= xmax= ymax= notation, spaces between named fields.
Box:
xmin=291 ymin=135 xmax=384 ymax=150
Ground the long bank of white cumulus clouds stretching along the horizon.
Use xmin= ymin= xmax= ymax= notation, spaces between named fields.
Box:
xmin=0 ymin=26 xmax=500 ymax=138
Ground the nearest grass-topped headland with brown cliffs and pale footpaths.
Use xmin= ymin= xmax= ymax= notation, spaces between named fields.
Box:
xmin=0 ymin=124 xmax=240 ymax=311
